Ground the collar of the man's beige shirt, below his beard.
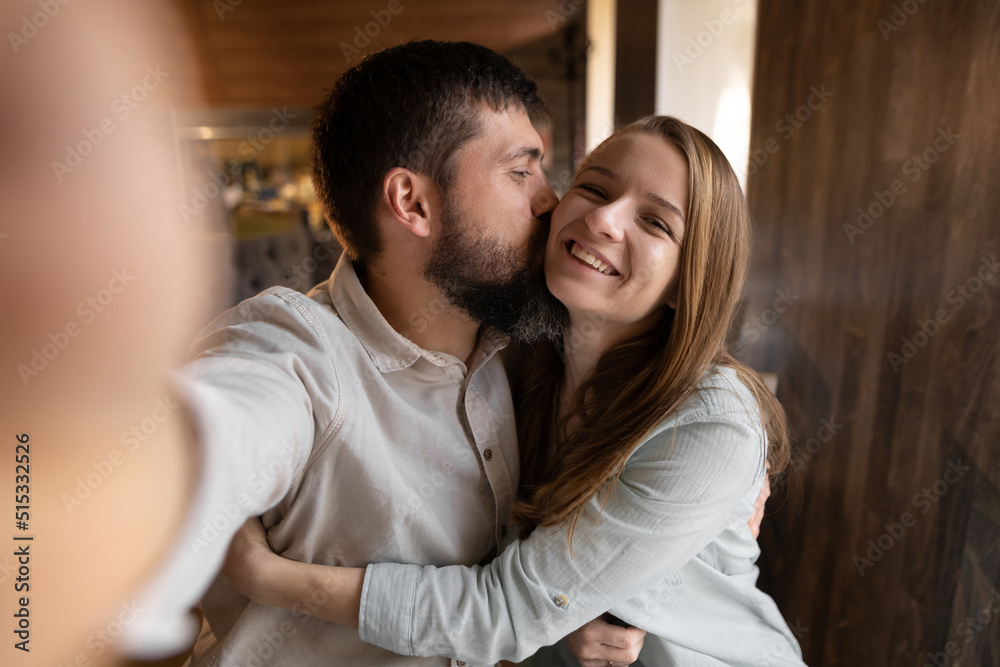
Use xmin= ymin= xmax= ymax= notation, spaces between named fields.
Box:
xmin=329 ymin=255 xmax=509 ymax=373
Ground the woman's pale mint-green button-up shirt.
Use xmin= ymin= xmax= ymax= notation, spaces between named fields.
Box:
xmin=360 ymin=368 xmax=803 ymax=667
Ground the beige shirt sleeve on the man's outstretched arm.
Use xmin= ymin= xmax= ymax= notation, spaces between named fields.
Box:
xmin=124 ymin=292 xmax=337 ymax=658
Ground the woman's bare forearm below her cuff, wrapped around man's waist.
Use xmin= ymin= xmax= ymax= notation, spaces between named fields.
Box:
xmin=222 ymin=517 xmax=365 ymax=629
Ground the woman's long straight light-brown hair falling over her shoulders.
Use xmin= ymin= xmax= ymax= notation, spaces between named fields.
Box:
xmin=514 ymin=116 xmax=789 ymax=545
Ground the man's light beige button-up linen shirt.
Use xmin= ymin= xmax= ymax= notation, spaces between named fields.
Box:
xmin=122 ymin=259 xmax=519 ymax=667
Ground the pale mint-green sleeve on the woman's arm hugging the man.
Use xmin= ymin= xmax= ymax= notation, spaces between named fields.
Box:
xmin=359 ymin=408 xmax=765 ymax=663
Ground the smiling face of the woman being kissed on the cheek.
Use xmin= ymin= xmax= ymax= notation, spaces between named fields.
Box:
xmin=545 ymin=133 xmax=688 ymax=347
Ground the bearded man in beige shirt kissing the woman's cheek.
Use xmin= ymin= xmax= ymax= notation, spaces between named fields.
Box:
xmin=123 ymin=42 xmax=641 ymax=666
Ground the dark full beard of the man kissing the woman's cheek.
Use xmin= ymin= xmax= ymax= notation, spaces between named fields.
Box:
xmin=424 ymin=196 xmax=569 ymax=343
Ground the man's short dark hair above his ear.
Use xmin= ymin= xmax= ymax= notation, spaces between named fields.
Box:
xmin=312 ymin=40 xmax=547 ymax=264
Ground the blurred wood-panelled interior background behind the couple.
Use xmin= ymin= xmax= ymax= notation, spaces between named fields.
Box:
xmin=0 ymin=0 xmax=1000 ymax=667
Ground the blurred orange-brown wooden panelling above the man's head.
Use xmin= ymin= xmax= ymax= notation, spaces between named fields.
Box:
xmin=171 ymin=0 xmax=583 ymax=107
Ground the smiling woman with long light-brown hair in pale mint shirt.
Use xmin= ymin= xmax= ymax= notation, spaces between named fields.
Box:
xmin=227 ymin=117 xmax=802 ymax=665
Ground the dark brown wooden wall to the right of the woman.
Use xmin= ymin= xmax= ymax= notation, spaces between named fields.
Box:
xmin=738 ymin=0 xmax=1000 ymax=665
